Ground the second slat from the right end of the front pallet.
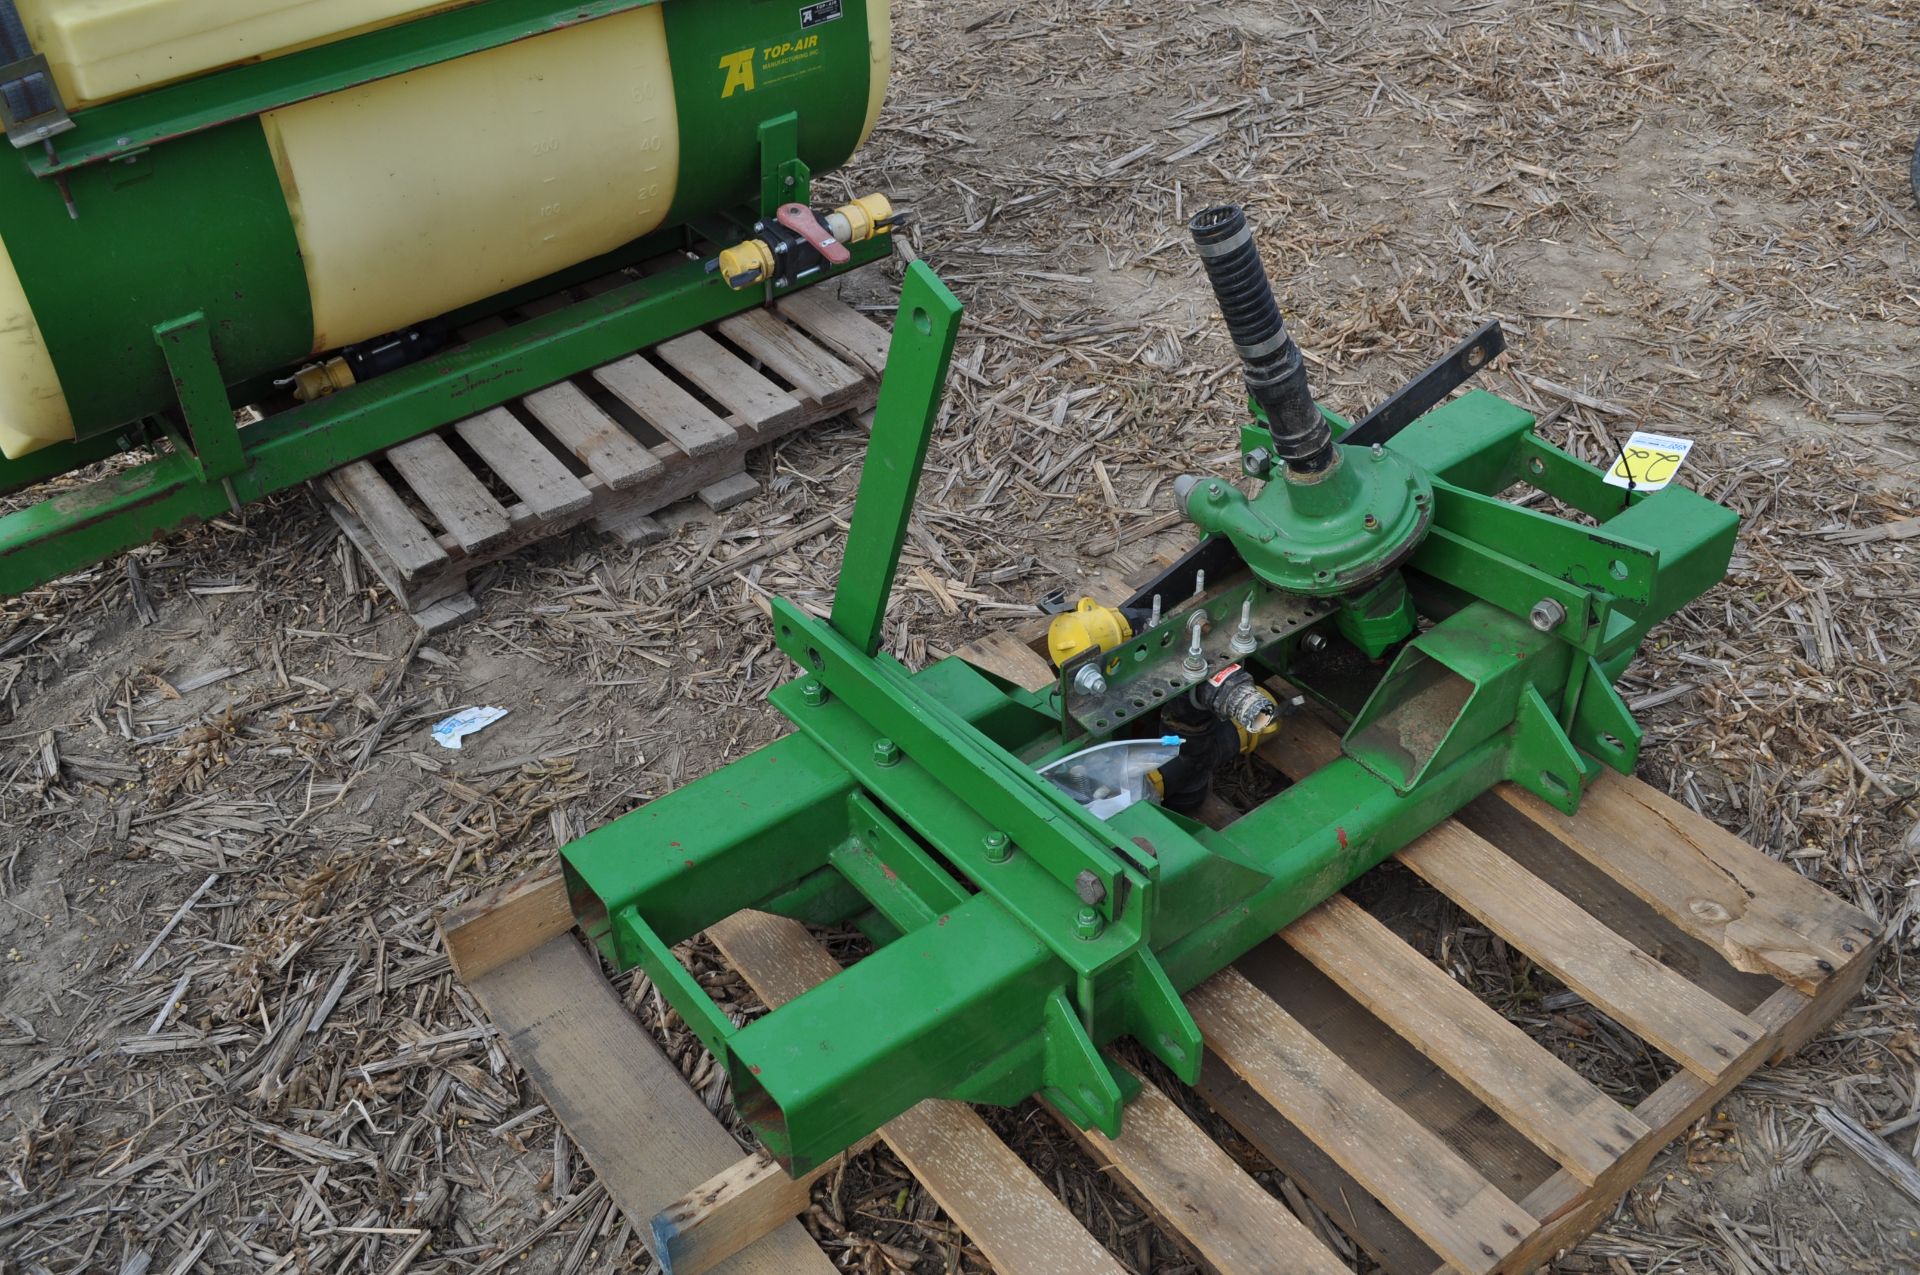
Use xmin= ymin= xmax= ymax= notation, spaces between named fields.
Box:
xmin=1400 ymin=820 xmax=1766 ymax=1081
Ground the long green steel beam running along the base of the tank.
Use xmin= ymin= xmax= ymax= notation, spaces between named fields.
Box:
xmin=0 ymin=236 xmax=893 ymax=593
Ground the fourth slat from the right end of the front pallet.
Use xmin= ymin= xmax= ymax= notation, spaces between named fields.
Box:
xmin=1187 ymin=968 xmax=1538 ymax=1275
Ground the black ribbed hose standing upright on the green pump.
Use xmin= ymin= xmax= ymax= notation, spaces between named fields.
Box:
xmin=1190 ymin=204 xmax=1334 ymax=474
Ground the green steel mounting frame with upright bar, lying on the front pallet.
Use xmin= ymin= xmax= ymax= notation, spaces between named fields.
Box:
xmin=563 ymin=263 xmax=1738 ymax=1171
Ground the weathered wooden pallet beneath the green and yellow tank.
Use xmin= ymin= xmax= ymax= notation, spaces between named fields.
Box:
xmin=317 ymin=277 xmax=889 ymax=632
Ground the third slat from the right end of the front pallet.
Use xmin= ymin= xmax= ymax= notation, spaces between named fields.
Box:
xmin=1281 ymin=895 xmax=1651 ymax=1185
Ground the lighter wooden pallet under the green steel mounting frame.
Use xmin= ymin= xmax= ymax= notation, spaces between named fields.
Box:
xmin=442 ymin=636 xmax=1878 ymax=1275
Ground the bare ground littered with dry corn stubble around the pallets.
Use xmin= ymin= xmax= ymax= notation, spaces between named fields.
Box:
xmin=0 ymin=0 xmax=1920 ymax=1275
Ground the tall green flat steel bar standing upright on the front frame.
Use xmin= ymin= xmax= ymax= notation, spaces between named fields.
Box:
xmin=833 ymin=261 xmax=960 ymax=655
